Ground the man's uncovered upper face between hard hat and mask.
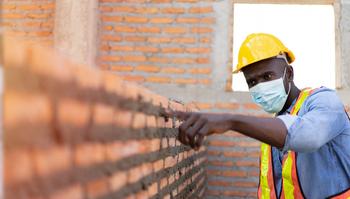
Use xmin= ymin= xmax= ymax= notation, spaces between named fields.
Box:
xmin=242 ymin=58 xmax=293 ymax=92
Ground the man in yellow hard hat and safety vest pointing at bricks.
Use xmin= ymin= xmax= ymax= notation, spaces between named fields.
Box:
xmin=171 ymin=33 xmax=350 ymax=199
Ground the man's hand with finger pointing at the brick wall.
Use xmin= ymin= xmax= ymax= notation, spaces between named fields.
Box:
xmin=167 ymin=111 xmax=232 ymax=150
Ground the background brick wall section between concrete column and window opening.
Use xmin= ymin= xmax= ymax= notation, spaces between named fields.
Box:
xmin=98 ymin=0 xmax=215 ymax=86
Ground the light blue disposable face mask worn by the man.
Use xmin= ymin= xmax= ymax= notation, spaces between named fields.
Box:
xmin=249 ymin=69 xmax=291 ymax=113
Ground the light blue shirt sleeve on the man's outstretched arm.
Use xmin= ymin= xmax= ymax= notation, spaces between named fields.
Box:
xmin=277 ymin=91 xmax=347 ymax=152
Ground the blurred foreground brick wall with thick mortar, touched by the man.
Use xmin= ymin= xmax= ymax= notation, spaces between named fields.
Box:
xmin=0 ymin=36 xmax=206 ymax=199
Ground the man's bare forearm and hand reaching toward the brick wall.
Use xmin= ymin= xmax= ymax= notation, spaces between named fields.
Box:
xmin=172 ymin=112 xmax=287 ymax=149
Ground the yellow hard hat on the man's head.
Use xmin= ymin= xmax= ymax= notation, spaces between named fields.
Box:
xmin=233 ymin=33 xmax=295 ymax=73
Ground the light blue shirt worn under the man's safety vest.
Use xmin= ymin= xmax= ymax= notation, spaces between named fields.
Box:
xmin=272 ymin=87 xmax=350 ymax=199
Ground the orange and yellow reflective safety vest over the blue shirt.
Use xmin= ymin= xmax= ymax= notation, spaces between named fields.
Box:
xmin=258 ymin=89 xmax=350 ymax=199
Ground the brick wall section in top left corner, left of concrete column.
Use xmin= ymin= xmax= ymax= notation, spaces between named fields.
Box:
xmin=0 ymin=0 xmax=55 ymax=46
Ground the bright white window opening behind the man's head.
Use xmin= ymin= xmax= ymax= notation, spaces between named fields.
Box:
xmin=232 ymin=4 xmax=335 ymax=91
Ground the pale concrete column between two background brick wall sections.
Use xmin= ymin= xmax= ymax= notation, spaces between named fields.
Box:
xmin=54 ymin=0 xmax=98 ymax=66
